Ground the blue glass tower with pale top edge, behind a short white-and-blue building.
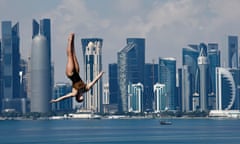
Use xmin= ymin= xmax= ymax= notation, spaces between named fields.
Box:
xmin=158 ymin=58 xmax=177 ymax=110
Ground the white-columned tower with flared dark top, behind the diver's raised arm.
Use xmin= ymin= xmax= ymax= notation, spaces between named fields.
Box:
xmin=81 ymin=38 xmax=103 ymax=112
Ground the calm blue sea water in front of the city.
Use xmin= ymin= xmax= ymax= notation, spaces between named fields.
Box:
xmin=0 ymin=119 xmax=240 ymax=144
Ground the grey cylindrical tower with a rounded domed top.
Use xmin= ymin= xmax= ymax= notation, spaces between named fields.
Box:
xmin=30 ymin=35 xmax=52 ymax=113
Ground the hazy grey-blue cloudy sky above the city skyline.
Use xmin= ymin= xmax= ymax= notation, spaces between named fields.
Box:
xmin=0 ymin=0 xmax=240 ymax=82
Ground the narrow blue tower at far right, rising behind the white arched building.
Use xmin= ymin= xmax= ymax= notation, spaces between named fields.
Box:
xmin=228 ymin=36 xmax=238 ymax=68
